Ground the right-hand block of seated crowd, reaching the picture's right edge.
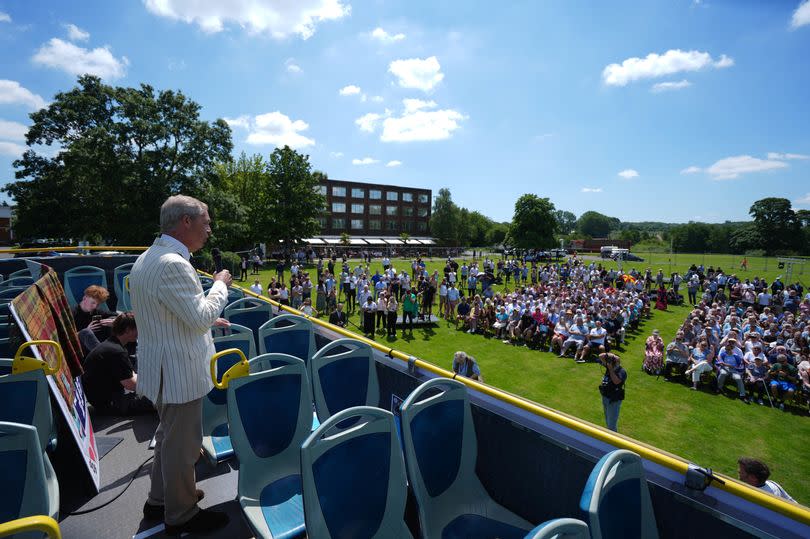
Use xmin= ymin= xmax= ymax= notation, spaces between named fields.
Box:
xmin=644 ymin=265 xmax=810 ymax=410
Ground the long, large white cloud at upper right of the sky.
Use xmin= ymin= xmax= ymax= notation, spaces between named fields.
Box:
xmin=602 ymin=49 xmax=734 ymax=86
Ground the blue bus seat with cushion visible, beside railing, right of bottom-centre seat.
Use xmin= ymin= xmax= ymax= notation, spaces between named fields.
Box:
xmin=402 ymin=378 xmax=534 ymax=539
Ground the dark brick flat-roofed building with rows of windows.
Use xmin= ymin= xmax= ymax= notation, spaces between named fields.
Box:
xmin=320 ymin=180 xmax=433 ymax=236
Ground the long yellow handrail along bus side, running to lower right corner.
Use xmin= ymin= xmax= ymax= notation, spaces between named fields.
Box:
xmin=215 ymin=272 xmax=810 ymax=525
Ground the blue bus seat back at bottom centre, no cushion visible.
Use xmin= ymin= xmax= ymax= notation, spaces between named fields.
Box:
xmin=301 ymin=406 xmax=412 ymax=539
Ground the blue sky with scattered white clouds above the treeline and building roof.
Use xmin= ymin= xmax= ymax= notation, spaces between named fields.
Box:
xmin=0 ymin=0 xmax=810 ymax=222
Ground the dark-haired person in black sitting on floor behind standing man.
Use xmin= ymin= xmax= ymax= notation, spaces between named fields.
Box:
xmin=82 ymin=312 xmax=155 ymax=416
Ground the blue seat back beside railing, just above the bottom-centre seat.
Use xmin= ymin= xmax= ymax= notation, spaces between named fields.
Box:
xmin=310 ymin=339 xmax=380 ymax=422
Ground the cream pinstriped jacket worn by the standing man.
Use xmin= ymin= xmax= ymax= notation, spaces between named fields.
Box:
xmin=129 ymin=238 xmax=228 ymax=404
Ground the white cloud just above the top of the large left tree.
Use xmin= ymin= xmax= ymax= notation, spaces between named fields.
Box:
xmin=32 ymin=37 xmax=129 ymax=79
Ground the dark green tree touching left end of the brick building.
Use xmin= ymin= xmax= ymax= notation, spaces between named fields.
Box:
xmin=262 ymin=146 xmax=326 ymax=252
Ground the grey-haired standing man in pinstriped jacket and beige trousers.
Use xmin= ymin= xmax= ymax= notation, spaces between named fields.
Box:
xmin=129 ymin=195 xmax=232 ymax=535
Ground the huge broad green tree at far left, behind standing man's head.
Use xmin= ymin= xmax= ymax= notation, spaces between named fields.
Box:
xmin=4 ymin=75 xmax=232 ymax=243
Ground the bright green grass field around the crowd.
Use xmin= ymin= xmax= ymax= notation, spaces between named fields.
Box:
xmin=245 ymin=253 xmax=810 ymax=505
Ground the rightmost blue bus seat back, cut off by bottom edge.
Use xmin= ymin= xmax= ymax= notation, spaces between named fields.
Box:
xmin=579 ymin=449 xmax=658 ymax=539
